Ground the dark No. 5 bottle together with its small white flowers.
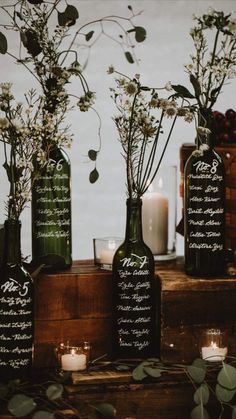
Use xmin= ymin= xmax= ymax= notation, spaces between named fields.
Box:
xmin=0 ymin=83 xmax=36 ymax=381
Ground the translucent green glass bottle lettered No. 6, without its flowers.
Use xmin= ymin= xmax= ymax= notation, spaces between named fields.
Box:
xmin=32 ymin=147 xmax=72 ymax=271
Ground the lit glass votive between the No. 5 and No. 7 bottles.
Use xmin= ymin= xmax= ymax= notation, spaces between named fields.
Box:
xmin=56 ymin=341 xmax=89 ymax=371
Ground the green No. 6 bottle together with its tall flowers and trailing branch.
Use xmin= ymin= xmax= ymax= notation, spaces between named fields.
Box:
xmin=0 ymin=0 xmax=146 ymax=270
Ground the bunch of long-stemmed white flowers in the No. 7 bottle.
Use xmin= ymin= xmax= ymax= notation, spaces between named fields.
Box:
xmin=108 ymin=66 xmax=194 ymax=198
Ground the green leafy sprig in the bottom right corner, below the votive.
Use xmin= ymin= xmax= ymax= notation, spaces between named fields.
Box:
xmin=132 ymin=357 xmax=236 ymax=419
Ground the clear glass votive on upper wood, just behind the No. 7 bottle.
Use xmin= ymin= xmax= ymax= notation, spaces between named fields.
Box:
xmin=93 ymin=237 xmax=124 ymax=270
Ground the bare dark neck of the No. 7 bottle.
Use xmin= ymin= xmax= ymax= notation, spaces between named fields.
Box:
xmin=125 ymin=198 xmax=143 ymax=242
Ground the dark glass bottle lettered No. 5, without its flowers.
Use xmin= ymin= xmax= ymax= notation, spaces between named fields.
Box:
xmin=0 ymin=220 xmax=34 ymax=381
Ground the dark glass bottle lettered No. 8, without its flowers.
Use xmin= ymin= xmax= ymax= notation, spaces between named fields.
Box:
xmin=184 ymin=126 xmax=225 ymax=277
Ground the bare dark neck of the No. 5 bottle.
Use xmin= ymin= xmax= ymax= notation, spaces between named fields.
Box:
xmin=3 ymin=220 xmax=21 ymax=264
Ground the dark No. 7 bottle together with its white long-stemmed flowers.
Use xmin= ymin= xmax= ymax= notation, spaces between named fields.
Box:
xmin=109 ymin=67 xmax=194 ymax=358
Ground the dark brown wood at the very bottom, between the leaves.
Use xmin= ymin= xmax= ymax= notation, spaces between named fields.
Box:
xmin=0 ymin=371 xmax=218 ymax=419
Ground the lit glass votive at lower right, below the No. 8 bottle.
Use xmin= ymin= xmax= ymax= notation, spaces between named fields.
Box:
xmin=200 ymin=328 xmax=228 ymax=362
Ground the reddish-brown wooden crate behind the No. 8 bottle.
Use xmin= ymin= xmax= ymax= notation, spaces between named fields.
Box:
xmin=178 ymin=143 xmax=236 ymax=250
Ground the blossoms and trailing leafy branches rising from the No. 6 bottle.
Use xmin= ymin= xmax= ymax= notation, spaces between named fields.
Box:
xmin=0 ymin=0 xmax=146 ymax=182
